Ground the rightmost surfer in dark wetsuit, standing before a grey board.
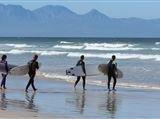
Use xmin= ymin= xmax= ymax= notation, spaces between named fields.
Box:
xmin=108 ymin=55 xmax=117 ymax=91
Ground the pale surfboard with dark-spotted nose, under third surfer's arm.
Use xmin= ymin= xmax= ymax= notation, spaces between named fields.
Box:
xmin=66 ymin=64 xmax=101 ymax=76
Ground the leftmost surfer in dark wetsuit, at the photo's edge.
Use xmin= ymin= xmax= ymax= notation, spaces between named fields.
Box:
xmin=0 ymin=55 xmax=9 ymax=89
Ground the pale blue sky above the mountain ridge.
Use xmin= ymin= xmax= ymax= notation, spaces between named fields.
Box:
xmin=0 ymin=0 xmax=160 ymax=19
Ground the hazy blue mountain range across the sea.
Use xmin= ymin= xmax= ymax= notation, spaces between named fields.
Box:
xmin=0 ymin=4 xmax=160 ymax=37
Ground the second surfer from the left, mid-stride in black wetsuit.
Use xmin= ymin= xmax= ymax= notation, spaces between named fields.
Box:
xmin=25 ymin=55 xmax=39 ymax=92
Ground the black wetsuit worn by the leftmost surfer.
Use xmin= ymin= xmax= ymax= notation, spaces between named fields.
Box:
xmin=0 ymin=61 xmax=9 ymax=89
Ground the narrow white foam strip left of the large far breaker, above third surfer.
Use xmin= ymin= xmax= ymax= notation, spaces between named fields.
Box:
xmin=53 ymin=45 xmax=84 ymax=49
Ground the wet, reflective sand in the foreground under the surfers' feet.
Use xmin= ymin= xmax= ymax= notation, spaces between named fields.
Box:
xmin=0 ymin=77 xmax=160 ymax=119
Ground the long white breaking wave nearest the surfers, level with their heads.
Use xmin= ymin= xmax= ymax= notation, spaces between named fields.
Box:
xmin=0 ymin=49 xmax=160 ymax=61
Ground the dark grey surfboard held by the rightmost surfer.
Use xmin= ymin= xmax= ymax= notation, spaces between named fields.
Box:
xmin=98 ymin=64 xmax=123 ymax=78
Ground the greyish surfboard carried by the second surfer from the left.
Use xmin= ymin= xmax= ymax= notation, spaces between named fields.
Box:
xmin=10 ymin=63 xmax=42 ymax=76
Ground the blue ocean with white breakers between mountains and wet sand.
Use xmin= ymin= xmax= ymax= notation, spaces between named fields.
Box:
xmin=0 ymin=37 xmax=160 ymax=89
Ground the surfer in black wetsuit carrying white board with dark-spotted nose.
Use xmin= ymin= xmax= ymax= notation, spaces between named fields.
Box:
xmin=74 ymin=55 xmax=86 ymax=90
